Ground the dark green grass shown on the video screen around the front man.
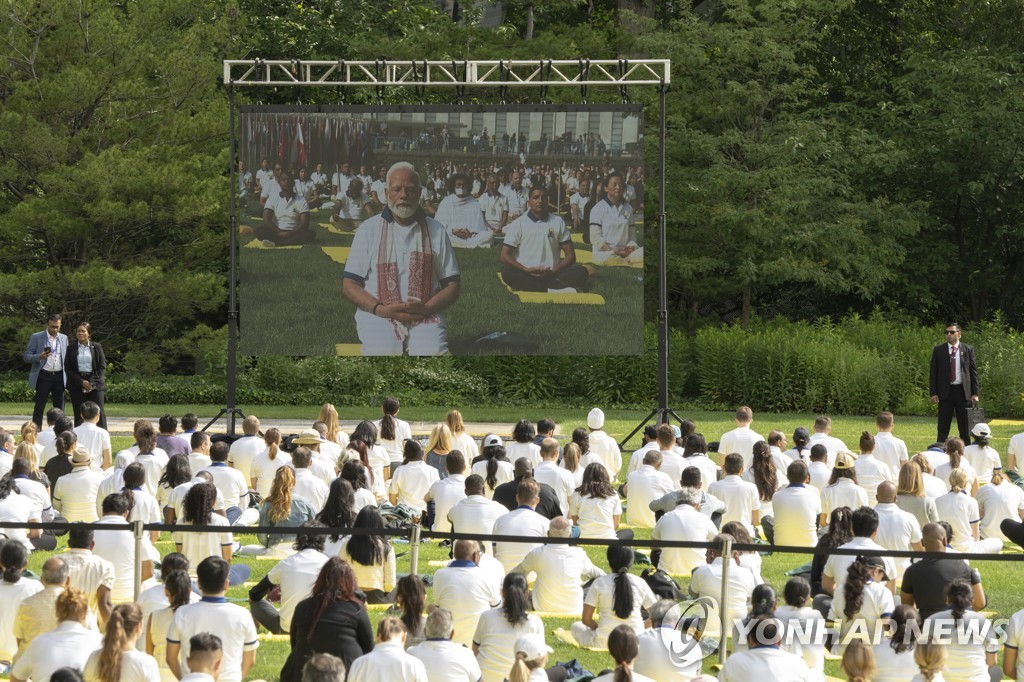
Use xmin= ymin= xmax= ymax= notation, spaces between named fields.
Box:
xmin=239 ymin=210 xmax=643 ymax=355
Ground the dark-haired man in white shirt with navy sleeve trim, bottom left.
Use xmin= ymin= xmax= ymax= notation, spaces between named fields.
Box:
xmin=167 ymin=556 xmax=259 ymax=682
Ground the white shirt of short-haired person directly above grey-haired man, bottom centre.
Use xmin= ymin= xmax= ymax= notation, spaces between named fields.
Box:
xmin=433 ymin=560 xmax=502 ymax=646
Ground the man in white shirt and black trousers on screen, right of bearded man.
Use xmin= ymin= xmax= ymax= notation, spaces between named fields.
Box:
xmin=502 ymin=187 xmax=590 ymax=293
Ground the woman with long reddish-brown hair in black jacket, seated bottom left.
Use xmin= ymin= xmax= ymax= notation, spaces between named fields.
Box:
xmin=281 ymin=556 xmax=374 ymax=682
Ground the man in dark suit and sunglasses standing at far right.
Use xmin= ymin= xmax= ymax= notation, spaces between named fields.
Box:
xmin=929 ymin=323 xmax=979 ymax=442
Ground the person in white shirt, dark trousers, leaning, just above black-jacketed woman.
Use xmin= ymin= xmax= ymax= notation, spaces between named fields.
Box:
xmin=249 ymin=520 xmax=328 ymax=635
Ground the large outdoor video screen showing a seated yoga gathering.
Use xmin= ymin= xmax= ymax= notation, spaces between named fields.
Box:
xmin=236 ymin=105 xmax=644 ymax=355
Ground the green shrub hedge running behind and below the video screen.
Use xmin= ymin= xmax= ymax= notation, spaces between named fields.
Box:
xmin=0 ymin=313 xmax=1024 ymax=418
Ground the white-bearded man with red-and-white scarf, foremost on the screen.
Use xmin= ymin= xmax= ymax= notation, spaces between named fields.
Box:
xmin=342 ymin=163 xmax=461 ymax=355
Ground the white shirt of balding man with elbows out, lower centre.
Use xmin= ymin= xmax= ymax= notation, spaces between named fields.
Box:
xmin=513 ymin=545 xmax=604 ymax=613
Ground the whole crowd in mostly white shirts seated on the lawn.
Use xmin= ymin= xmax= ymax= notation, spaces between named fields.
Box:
xmin=0 ymin=398 xmax=1024 ymax=682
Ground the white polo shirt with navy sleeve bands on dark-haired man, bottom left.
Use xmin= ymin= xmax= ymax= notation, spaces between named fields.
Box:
xmin=167 ymin=593 xmax=259 ymax=682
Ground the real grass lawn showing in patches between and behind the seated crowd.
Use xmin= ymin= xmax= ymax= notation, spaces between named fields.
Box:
xmin=14 ymin=403 xmax=1024 ymax=680
